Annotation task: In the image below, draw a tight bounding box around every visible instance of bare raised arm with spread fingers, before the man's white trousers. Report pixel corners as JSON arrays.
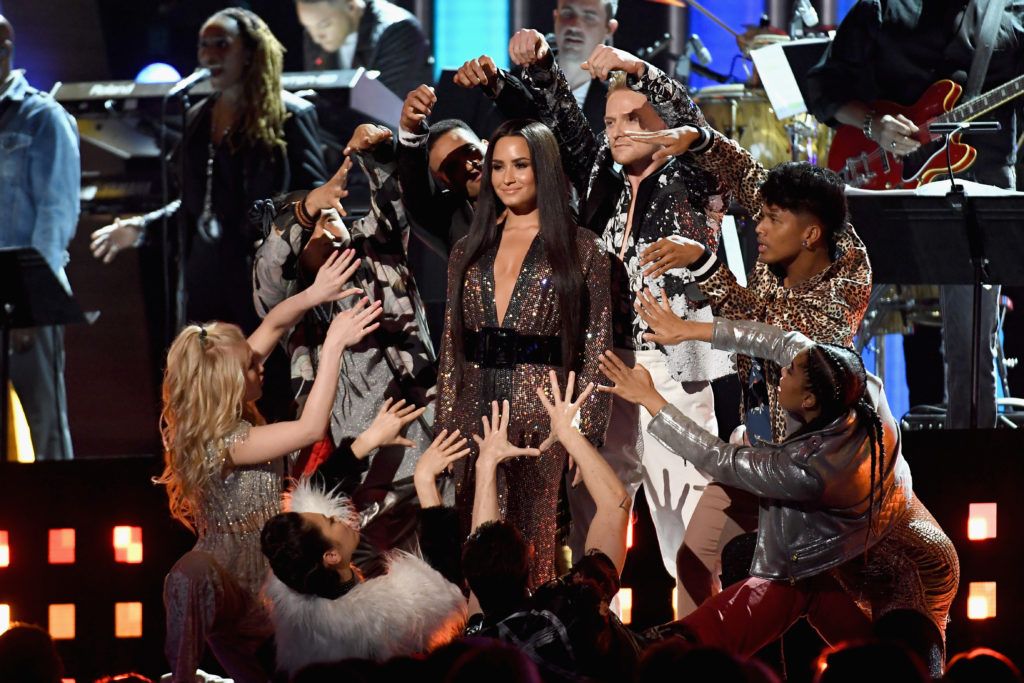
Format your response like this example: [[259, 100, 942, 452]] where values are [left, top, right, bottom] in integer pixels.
[[537, 371, 632, 573]]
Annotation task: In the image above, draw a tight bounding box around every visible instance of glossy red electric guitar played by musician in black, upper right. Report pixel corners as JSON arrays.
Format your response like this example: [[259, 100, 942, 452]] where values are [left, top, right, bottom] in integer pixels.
[[828, 76, 1024, 189]]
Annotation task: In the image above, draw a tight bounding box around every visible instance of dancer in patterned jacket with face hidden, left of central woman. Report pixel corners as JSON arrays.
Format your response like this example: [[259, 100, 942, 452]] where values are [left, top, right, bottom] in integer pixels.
[[253, 124, 437, 574]]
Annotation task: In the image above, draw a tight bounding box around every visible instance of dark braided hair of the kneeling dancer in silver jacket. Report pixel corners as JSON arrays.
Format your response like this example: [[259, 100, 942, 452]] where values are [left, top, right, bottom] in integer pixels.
[[807, 344, 886, 540]]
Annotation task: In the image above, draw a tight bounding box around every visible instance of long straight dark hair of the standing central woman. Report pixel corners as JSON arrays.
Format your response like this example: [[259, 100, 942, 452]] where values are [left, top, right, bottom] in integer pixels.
[[449, 120, 587, 378]]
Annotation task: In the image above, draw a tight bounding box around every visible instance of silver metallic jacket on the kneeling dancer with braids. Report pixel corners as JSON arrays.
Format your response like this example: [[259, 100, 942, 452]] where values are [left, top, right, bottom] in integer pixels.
[[647, 317, 913, 581]]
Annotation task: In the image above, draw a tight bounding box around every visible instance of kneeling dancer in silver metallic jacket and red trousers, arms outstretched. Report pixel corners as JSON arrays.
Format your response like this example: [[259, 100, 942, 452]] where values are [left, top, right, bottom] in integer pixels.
[[601, 318, 959, 674]]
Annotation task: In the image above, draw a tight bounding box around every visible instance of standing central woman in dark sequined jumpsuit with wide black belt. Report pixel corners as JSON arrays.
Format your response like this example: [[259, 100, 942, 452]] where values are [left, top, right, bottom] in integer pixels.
[[435, 121, 611, 586]]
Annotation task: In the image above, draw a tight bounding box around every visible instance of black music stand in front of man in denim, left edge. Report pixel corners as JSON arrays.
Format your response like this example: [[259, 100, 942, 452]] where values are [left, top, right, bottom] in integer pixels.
[[0, 247, 99, 462]]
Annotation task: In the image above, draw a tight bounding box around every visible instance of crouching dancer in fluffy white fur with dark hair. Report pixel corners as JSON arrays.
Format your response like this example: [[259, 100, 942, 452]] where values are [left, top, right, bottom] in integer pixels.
[[261, 434, 469, 677]]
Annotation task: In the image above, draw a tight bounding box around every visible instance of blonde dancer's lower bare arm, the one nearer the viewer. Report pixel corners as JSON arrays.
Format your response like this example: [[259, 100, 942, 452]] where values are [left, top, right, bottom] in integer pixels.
[[229, 299, 381, 465]]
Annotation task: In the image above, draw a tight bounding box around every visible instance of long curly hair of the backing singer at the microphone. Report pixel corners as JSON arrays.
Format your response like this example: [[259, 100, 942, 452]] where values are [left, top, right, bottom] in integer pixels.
[[204, 7, 289, 150]]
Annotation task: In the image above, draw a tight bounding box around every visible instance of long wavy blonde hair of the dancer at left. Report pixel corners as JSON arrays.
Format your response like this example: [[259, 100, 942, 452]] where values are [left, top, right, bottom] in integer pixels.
[[155, 323, 263, 530]]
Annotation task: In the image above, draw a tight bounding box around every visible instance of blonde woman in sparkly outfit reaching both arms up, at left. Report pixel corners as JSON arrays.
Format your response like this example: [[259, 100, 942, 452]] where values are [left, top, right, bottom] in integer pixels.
[[159, 250, 380, 683]]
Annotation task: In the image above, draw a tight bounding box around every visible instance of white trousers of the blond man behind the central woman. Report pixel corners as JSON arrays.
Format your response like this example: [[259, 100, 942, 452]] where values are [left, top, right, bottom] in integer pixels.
[[568, 349, 718, 578]]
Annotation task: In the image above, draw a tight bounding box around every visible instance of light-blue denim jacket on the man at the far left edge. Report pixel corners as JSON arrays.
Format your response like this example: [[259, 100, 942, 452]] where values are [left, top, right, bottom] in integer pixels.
[[0, 66, 81, 287]]
